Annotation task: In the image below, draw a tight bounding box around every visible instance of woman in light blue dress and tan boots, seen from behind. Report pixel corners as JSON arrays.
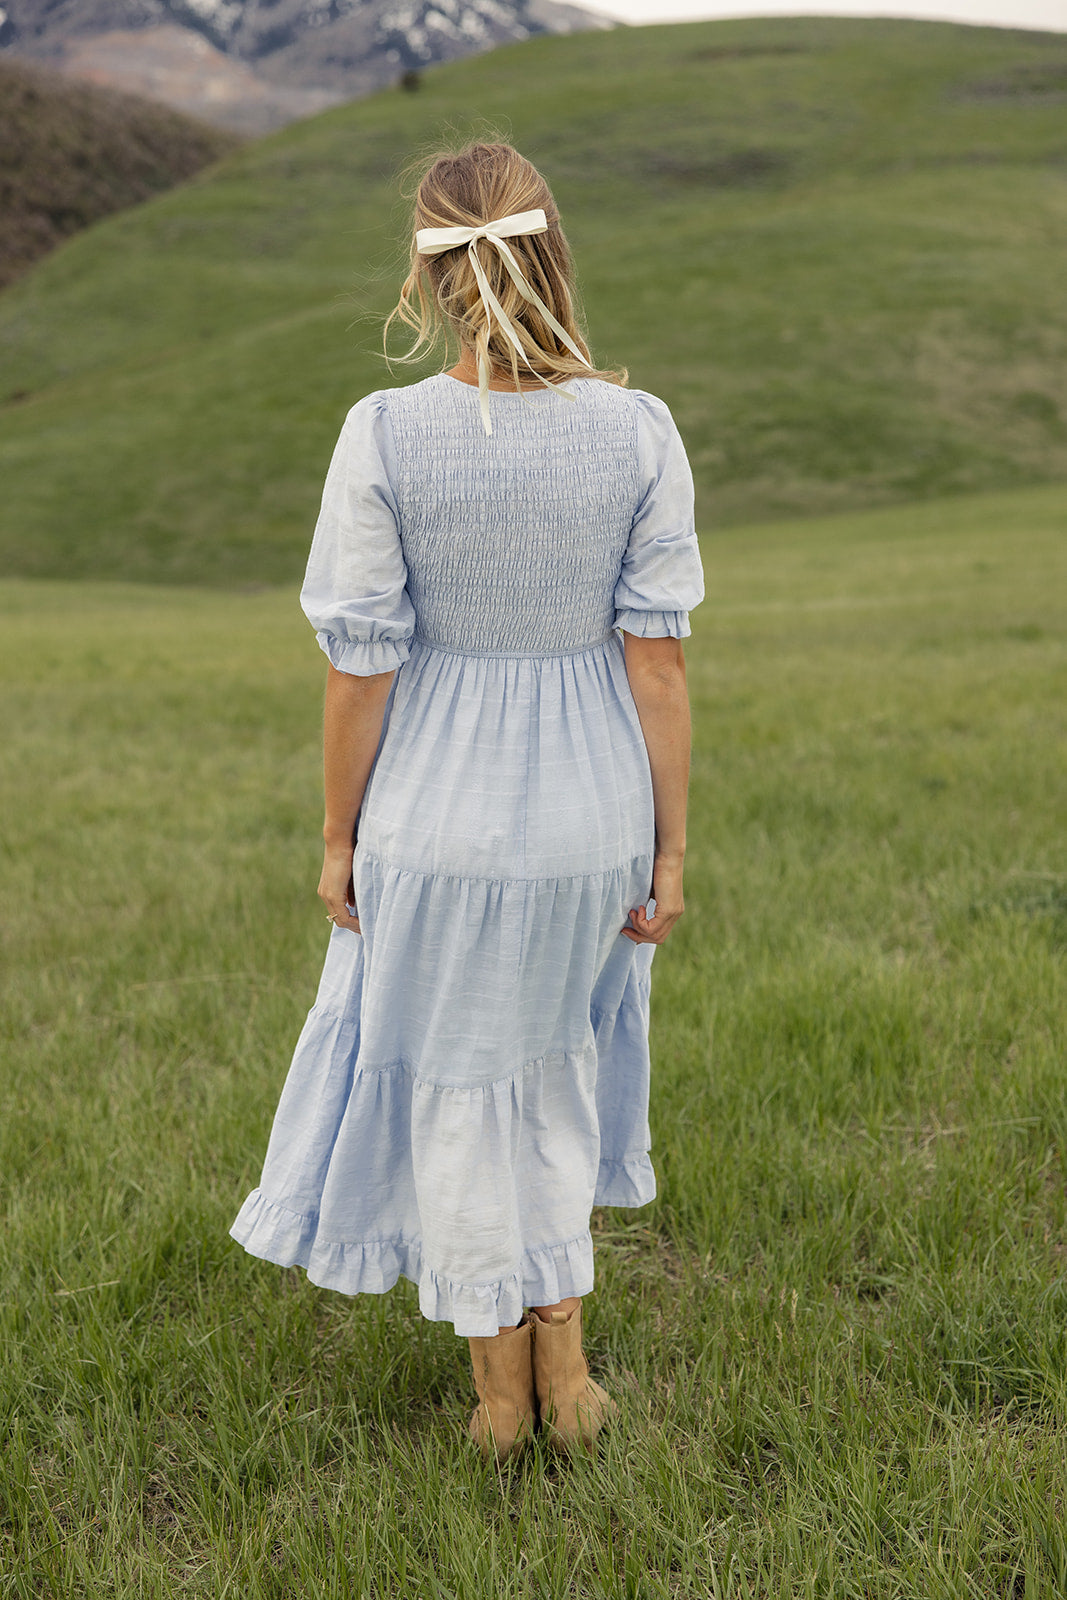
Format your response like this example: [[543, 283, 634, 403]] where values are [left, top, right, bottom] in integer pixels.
[[232, 144, 702, 1458]]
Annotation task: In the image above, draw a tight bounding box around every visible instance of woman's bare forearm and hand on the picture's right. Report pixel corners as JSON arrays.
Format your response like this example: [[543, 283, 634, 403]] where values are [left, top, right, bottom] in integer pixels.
[[622, 632, 691, 944]]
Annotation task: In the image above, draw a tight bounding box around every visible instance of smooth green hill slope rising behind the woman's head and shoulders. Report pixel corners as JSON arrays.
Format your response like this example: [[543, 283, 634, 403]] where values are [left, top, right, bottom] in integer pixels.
[[0, 18, 1067, 586]]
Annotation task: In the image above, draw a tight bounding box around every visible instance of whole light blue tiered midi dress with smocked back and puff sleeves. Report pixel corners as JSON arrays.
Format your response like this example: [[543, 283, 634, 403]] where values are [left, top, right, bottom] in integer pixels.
[[232, 374, 704, 1334]]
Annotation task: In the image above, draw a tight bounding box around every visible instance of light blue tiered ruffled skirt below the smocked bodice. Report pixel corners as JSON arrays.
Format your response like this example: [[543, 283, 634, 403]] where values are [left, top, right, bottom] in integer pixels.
[[232, 635, 656, 1336]]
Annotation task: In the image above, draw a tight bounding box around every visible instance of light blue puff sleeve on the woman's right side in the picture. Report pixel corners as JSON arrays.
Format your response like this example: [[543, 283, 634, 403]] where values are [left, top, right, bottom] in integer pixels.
[[614, 390, 704, 638]]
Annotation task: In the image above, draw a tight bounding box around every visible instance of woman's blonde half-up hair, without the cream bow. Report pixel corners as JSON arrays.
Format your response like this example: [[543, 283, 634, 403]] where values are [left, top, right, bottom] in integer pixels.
[[382, 142, 627, 389]]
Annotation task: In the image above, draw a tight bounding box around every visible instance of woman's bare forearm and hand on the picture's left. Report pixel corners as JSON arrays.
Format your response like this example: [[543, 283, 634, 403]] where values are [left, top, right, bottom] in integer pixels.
[[318, 666, 395, 933]]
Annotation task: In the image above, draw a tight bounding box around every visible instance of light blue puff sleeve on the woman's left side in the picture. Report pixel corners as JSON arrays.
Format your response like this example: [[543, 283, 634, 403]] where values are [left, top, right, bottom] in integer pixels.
[[301, 394, 414, 677]]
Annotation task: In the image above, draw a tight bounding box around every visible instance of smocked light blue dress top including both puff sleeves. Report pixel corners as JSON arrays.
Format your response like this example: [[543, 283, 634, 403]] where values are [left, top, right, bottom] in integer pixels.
[[301, 376, 704, 675]]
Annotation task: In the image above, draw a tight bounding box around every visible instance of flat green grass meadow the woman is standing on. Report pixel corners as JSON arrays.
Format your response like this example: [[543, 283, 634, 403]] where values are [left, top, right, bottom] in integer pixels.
[[0, 490, 1067, 1600]]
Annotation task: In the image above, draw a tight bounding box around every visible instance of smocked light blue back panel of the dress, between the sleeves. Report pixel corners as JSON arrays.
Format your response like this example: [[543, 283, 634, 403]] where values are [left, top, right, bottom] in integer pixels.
[[389, 378, 638, 654]]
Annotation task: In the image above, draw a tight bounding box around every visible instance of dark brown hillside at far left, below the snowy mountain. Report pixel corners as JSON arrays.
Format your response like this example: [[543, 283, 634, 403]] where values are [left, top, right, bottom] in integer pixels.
[[0, 58, 235, 286]]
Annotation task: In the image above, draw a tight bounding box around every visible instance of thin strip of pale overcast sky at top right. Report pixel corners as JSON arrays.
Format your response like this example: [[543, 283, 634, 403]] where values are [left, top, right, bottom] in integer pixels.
[[576, 0, 1067, 34]]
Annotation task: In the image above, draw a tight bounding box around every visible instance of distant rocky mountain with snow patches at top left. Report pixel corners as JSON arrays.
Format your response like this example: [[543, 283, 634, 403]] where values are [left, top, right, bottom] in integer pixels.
[[0, 0, 609, 133]]
